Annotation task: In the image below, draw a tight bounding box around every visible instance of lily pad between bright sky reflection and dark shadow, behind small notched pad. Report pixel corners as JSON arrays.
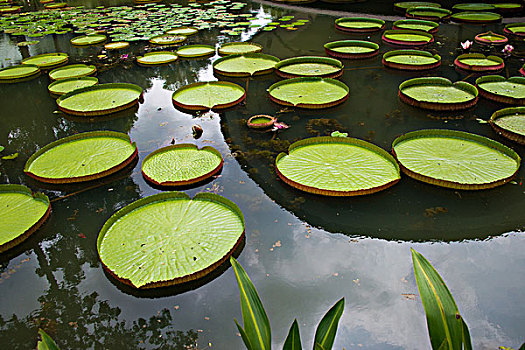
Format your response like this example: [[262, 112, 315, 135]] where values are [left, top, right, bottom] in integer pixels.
[[172, 81, 246, 111]]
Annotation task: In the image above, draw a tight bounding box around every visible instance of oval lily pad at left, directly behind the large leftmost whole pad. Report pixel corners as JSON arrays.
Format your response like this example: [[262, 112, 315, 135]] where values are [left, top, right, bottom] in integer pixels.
[[57, 83, 142, 116]]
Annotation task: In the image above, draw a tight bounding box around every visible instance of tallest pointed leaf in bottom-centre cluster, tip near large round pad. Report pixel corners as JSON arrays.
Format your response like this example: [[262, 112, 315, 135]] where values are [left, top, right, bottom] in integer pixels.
[[230, 258, 271, 350]]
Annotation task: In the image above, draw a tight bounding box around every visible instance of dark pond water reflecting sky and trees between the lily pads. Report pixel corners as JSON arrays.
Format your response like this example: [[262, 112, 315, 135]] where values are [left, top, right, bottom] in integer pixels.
[[0, 1, 525, 349]]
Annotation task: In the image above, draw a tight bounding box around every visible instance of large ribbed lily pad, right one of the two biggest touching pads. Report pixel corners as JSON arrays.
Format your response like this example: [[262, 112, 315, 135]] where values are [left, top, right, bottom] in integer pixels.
[[392, 130, 521, 190]]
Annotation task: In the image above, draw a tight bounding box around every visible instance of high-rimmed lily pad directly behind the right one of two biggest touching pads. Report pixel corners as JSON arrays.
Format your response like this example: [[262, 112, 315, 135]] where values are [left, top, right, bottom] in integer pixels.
[[399, 77, 478, 111]]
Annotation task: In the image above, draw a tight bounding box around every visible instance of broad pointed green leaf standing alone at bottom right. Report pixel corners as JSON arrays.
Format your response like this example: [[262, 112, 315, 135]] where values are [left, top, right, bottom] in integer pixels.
[[412, 249, 464, 349]]
